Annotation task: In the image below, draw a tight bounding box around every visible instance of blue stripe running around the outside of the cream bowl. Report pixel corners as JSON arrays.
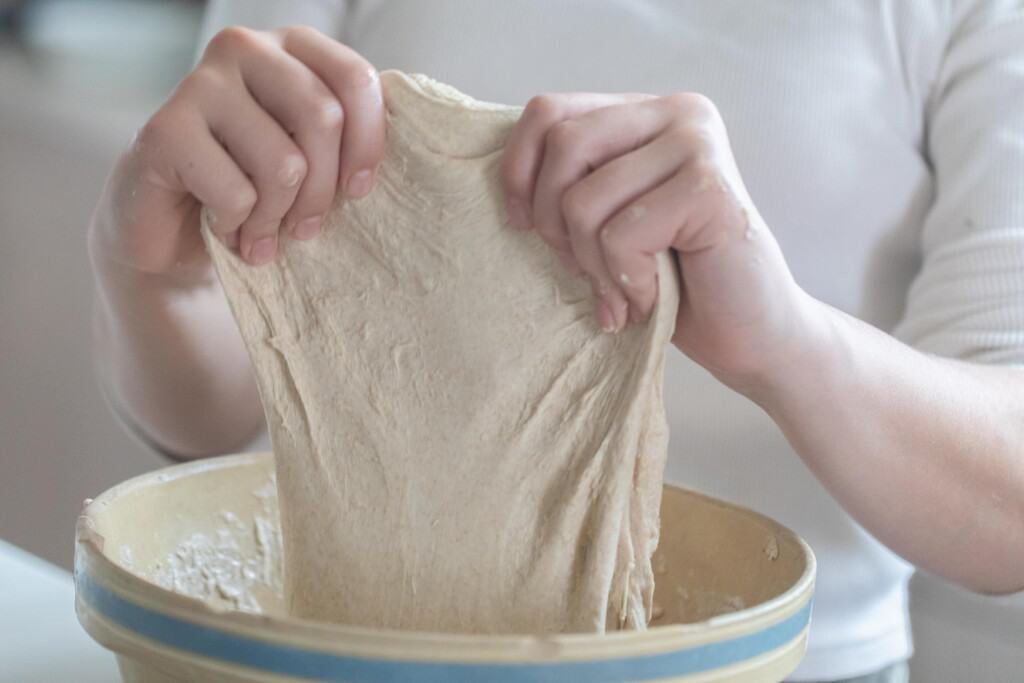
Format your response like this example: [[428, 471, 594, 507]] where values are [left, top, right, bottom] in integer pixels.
[[76, 572, 811, 683]]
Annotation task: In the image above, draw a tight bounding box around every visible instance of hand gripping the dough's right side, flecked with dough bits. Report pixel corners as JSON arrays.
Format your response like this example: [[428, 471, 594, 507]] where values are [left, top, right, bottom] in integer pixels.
[[502, 93, 807, 385]]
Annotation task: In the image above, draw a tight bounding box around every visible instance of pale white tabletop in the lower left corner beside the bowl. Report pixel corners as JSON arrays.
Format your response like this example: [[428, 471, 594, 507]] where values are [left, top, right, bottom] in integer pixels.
[[0, 541, 121, 683]]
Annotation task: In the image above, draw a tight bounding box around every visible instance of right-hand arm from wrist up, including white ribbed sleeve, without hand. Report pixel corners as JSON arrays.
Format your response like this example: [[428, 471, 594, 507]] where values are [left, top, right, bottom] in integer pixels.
[[752, 2, 1024, 593]]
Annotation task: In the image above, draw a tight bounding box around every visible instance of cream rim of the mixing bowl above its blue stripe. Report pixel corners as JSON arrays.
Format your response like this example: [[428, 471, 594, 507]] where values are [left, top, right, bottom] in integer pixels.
[[75, 452, 817, 661]]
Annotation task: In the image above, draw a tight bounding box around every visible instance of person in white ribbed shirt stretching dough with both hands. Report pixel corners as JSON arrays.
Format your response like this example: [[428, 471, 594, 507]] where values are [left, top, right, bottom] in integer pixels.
[[90, 0, 1024, 681]]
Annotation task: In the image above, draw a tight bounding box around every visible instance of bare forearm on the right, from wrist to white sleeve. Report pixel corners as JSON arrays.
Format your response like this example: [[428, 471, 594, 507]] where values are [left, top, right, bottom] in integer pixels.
[[752, 300, 1024, 593]]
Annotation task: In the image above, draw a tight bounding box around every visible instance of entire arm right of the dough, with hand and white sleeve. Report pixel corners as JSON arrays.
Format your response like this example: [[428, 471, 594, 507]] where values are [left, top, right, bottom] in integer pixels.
[[503, 3, 1024, 593]]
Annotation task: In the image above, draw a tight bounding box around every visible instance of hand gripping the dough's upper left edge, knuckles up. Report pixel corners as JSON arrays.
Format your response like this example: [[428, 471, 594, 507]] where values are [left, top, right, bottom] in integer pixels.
[[90, 27, 385, 275]]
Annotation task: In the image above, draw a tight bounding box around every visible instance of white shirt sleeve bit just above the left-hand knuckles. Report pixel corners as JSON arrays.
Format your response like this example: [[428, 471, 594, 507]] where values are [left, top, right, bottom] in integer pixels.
[[199, 0, 345, 54]]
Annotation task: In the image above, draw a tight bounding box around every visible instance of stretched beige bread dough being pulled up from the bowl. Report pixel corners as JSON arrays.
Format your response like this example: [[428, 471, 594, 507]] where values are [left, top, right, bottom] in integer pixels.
[[204, 72, 678, 633]]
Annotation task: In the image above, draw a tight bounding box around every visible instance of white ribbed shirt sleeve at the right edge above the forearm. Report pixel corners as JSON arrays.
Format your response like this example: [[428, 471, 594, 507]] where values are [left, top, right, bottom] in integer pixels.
[[893, 0, 1024, 365]]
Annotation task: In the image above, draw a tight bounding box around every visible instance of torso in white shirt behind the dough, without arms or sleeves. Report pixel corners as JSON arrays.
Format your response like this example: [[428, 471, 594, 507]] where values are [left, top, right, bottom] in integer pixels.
[[211, 0, 950, 677]]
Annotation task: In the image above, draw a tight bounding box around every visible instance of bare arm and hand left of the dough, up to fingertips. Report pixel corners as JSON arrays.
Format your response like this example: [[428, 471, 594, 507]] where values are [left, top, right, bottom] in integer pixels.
[[89, 22, 384, 456]]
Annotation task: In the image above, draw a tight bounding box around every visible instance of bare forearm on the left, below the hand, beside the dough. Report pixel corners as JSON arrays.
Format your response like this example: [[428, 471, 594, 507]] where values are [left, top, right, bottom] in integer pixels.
[[91, 217, 263, 456]]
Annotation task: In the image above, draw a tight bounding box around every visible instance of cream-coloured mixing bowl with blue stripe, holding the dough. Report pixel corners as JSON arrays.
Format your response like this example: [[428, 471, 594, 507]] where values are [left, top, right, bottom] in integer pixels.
[[75, 454, 814, 683]]
